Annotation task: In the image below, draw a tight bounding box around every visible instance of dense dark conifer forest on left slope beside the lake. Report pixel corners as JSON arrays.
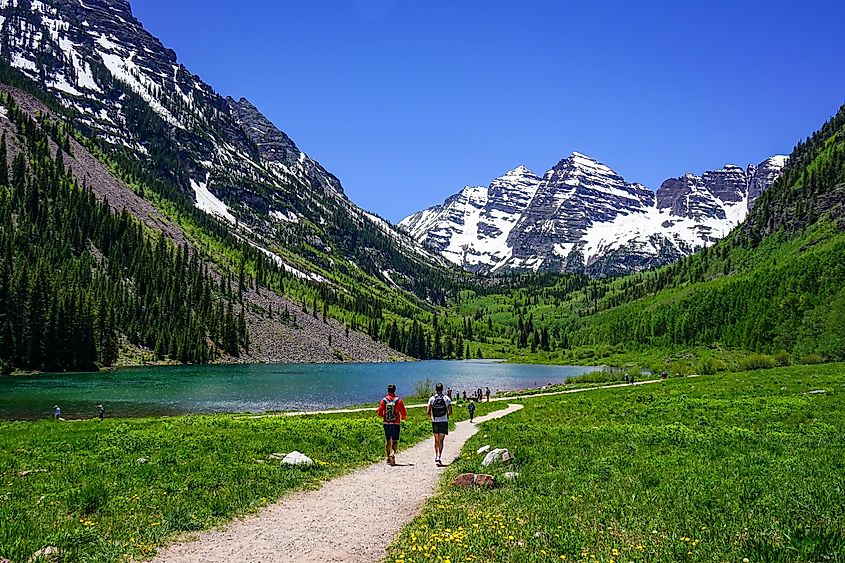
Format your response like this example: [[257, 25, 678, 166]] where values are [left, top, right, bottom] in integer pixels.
[[0, 95, 248, 371]]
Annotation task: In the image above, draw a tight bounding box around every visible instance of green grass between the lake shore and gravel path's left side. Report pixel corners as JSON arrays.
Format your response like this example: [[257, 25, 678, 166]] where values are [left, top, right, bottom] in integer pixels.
[[0, 404, 502, 562]]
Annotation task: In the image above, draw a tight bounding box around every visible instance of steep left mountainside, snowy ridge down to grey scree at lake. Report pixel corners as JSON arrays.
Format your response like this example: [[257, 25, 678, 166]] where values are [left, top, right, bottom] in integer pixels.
[[0, 0, 458, 361]]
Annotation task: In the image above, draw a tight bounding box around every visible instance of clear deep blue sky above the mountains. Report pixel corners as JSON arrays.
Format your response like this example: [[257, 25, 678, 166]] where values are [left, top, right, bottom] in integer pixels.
[[132, 0, 845, 225]]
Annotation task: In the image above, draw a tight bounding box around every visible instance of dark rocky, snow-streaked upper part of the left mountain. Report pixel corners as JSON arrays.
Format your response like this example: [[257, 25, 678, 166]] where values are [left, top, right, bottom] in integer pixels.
[[0, 0, 443, 285]]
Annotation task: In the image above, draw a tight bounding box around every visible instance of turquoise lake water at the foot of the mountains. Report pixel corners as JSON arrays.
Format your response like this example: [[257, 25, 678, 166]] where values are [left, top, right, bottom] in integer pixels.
[[0, 360, 597, 420]]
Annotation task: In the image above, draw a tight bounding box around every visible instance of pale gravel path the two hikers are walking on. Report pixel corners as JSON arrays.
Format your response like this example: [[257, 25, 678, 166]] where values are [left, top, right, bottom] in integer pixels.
[[153, 404, 522, 563]]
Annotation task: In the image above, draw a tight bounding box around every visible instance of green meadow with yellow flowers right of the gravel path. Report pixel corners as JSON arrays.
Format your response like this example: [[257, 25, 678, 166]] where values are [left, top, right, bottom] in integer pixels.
[[390, 364, 845, 563]]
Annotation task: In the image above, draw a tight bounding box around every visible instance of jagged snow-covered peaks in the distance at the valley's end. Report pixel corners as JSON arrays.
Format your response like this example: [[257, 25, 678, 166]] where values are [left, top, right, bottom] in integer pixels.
[[399, 152, 786, 275]]
